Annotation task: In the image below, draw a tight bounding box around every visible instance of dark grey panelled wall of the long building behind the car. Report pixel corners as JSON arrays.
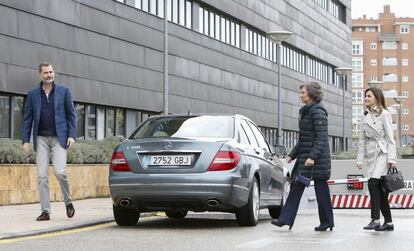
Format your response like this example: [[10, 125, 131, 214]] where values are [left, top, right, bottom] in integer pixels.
[[0, 0, 351, 151]]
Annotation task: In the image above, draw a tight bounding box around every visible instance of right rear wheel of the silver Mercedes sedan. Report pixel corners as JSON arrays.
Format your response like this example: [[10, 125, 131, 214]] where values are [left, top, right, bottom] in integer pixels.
[[236, 179, 260, 226]]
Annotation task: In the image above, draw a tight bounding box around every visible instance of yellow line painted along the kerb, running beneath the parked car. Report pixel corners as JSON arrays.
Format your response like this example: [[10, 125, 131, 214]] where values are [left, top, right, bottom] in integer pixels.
[[0, 216, 159, 245]]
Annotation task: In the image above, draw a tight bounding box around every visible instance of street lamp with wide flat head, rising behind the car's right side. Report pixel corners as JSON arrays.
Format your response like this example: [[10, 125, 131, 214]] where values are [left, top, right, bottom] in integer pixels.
[[266, 31, 292, 145]]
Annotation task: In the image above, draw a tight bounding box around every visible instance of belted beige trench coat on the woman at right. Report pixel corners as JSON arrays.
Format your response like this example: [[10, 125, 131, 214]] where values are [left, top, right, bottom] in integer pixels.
[[357, 109, 397, 179]]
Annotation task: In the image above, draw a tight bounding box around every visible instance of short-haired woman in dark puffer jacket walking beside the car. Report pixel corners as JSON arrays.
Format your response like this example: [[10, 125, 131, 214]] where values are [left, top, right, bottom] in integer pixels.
[[272, 82, 334, 231]]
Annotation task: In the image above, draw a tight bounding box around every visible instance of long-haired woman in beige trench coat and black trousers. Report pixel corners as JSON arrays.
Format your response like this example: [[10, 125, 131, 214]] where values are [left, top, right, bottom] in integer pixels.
[[357, 87, 397, 231]]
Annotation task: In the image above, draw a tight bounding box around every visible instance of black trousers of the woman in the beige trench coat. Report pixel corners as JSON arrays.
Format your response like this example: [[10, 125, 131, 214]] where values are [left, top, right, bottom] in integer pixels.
[[368, 178, 392, 222]]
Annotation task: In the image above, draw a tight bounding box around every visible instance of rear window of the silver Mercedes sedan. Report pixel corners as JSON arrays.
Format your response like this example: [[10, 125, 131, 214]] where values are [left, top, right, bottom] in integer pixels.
[[131, 116, 234, 139]]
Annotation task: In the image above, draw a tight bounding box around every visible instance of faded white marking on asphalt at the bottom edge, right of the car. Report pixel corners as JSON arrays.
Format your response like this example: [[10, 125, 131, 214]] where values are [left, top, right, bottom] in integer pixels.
[[236, 237, 345, 248]]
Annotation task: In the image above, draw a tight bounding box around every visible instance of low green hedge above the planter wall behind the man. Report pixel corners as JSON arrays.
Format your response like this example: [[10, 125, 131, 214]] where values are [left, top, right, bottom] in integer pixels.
[[0, 137, 123, 164]]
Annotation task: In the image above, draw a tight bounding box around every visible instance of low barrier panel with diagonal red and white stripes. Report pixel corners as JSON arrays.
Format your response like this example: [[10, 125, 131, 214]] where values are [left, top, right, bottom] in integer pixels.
[[331, 194, 414, 208]]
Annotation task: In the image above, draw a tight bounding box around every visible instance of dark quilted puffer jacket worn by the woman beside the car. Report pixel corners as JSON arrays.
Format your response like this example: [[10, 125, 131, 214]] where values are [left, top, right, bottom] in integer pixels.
[[289, 103, 331, 180]]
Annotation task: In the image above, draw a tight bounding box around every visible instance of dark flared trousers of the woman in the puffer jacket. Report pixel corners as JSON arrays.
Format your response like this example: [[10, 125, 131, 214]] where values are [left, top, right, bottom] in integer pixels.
[[278, 180, 334, 226]]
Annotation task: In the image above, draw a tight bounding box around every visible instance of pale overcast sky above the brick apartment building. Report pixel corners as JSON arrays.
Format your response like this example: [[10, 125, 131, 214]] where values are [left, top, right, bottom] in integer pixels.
[[351, 0, 414, 19]]
